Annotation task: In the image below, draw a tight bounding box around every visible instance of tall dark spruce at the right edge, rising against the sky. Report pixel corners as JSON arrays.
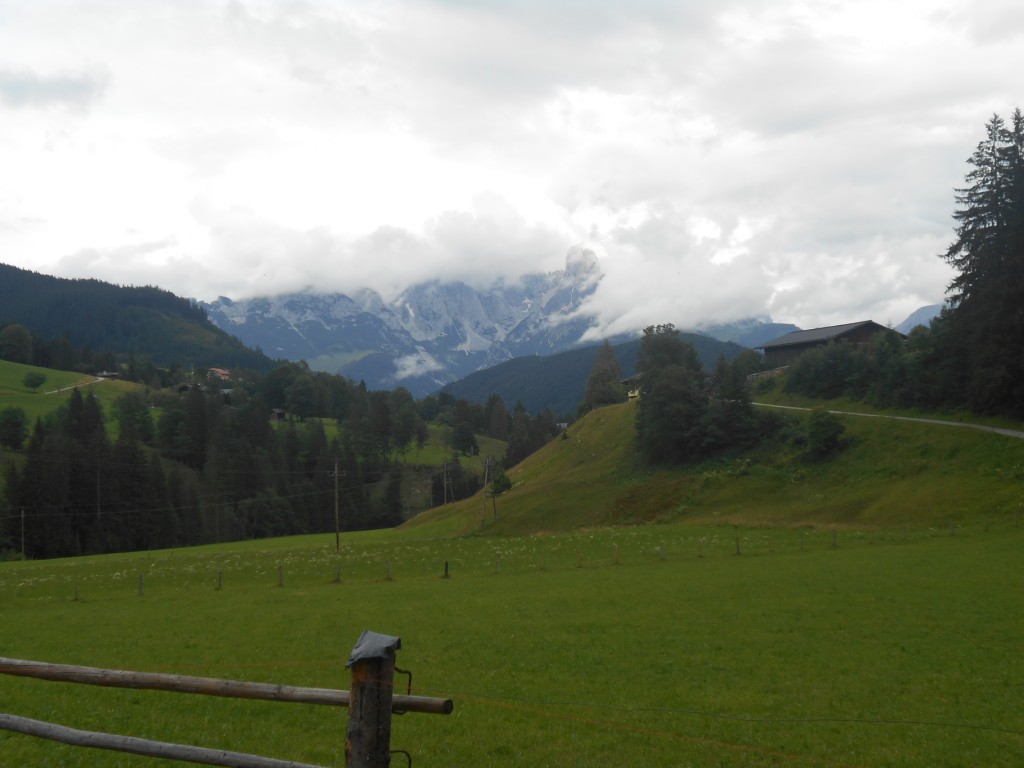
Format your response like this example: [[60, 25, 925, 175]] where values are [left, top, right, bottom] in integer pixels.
[[943, 109, 1024, 417]]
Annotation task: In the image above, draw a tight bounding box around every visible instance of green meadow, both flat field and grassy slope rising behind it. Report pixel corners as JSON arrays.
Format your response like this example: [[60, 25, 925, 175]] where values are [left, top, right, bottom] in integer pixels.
[[0, 367, 1024, 768]]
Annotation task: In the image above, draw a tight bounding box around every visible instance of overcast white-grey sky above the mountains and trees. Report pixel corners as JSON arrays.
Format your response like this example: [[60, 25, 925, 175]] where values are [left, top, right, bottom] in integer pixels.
[[0, 0, 1024, 332]]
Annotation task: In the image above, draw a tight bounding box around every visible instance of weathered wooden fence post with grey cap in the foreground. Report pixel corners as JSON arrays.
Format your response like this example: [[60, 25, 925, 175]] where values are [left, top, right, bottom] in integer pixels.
[[345, 630, 401, 768]]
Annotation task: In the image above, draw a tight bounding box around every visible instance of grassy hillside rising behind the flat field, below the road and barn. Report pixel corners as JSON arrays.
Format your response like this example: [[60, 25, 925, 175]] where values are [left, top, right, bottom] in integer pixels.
[[407, 393, 1024, 535]]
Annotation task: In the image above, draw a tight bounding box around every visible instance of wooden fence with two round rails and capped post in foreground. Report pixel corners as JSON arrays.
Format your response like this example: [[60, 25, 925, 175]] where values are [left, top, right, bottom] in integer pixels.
[[0, 631, 454, 768]]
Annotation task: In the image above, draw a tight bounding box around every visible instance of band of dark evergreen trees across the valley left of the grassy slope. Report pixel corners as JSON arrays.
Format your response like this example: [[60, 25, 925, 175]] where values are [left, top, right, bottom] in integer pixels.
[[0, 362, 554, 558]]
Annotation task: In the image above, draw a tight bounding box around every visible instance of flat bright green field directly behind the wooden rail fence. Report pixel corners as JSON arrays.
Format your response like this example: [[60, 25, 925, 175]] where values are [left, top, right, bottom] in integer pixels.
[[0, 524, 1024, 767]]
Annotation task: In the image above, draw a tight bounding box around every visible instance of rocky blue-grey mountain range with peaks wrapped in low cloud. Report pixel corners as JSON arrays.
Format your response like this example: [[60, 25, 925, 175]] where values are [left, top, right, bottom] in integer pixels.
[[202, 248, 819, 397]]
